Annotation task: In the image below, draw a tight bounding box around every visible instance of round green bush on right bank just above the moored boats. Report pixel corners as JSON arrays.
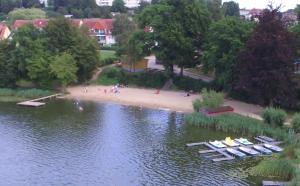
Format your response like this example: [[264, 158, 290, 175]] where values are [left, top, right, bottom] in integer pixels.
[[262, 107, 287, 127]]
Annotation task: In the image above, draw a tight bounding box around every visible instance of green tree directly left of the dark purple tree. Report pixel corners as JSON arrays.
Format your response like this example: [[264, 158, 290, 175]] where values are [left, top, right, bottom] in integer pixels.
[[203, 17, 253, 89]]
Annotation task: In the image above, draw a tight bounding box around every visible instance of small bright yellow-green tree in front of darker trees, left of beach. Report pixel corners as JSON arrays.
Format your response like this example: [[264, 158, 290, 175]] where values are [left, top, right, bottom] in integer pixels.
[[50, 53, 78, 87]]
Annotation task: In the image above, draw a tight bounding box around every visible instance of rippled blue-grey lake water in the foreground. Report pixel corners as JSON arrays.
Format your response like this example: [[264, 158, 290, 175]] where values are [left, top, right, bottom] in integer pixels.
[[0, 100, 260, 186]]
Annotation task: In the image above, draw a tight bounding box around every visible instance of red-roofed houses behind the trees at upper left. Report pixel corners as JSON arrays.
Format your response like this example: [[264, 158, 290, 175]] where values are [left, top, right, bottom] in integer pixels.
[[0, 18, 116, 45]]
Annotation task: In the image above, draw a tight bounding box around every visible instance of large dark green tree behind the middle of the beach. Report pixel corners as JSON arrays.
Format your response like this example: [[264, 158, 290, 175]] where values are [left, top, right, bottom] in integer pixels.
[[138, 0, 210, 72]]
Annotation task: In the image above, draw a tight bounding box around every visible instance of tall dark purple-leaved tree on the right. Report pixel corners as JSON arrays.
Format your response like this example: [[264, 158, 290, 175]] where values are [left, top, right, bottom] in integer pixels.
[[235, 9, 295, 106]]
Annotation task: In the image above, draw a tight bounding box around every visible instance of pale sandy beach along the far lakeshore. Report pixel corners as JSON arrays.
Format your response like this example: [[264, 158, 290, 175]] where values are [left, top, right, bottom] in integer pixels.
[[66, 86, 262, 119]]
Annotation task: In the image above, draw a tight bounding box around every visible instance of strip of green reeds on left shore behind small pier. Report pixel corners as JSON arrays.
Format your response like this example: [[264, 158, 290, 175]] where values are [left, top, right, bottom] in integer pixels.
[[0, 88, 53, 102]]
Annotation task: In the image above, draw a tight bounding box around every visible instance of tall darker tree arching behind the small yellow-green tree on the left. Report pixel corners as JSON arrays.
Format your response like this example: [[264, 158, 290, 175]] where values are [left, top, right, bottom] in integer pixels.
[[45, 18, 99, 82]]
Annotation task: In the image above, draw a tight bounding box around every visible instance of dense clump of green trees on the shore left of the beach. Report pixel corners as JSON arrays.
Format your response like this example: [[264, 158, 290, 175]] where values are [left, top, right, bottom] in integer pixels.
[[0, 19, 100, 87]]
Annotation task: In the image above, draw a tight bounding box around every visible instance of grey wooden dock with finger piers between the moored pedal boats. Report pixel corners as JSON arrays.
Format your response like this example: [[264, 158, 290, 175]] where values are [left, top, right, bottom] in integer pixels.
[[186, 137, 281, 162]]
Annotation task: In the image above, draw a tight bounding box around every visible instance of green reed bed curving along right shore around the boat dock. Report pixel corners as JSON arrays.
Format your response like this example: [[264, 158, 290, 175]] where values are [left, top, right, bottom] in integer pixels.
[[185, 113, 300, 183]]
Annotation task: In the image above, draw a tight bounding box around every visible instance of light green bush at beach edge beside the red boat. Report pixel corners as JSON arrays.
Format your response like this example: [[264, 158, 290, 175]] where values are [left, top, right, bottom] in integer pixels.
[[201, 89, 224, 108]]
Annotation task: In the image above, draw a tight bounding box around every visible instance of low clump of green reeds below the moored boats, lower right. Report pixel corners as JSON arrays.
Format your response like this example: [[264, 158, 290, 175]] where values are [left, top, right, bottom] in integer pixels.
[[250, 159, 295, 180]]
